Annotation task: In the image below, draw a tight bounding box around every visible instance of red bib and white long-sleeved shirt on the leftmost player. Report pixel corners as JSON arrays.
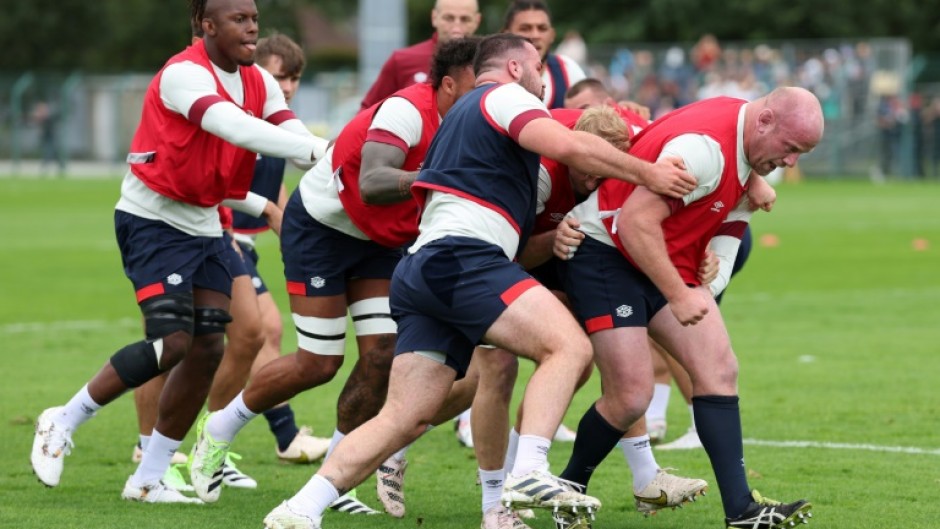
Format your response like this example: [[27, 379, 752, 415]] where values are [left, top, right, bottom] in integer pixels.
[[116, 40, 326, 236]]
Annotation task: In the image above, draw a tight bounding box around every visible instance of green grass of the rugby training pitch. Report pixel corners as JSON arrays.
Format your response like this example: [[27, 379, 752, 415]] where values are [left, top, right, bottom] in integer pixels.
[[0, 179, 940, 529]]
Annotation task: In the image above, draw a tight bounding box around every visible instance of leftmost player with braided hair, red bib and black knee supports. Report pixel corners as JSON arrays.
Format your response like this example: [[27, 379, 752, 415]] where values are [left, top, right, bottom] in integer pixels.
[[30, 0, 327, 503]]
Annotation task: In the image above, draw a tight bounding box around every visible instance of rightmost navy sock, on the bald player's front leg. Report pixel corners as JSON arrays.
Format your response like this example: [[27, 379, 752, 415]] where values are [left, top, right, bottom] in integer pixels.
[[692, 395, 751, 518]]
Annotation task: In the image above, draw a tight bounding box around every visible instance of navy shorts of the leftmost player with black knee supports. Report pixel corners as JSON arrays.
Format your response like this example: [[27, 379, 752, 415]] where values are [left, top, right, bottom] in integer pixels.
[[114, 210, 232, 303]]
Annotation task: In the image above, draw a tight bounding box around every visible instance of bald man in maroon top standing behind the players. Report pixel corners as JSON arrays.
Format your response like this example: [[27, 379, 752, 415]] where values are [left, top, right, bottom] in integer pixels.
[[360, 0, 480, 109]]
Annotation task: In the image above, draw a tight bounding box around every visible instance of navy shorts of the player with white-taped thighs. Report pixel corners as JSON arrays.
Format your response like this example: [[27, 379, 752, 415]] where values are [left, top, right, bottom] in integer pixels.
[[281, 191, 402, 296]]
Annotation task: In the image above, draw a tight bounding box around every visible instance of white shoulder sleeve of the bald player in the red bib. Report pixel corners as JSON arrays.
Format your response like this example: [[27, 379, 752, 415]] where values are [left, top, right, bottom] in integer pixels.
[[657, 134, 725, 205]]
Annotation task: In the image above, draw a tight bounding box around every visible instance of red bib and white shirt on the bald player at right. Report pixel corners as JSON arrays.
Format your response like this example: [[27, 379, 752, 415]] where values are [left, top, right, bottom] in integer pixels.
[[574, 98, 751, 285]]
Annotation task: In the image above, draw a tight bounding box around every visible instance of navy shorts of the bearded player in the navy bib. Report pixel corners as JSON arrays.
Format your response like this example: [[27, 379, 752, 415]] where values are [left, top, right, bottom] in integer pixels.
[[389, 237, 539, 378]]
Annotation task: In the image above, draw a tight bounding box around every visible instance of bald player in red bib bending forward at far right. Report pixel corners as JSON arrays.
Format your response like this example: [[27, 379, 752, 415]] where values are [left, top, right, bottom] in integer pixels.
[[561, 87, 823, 529]]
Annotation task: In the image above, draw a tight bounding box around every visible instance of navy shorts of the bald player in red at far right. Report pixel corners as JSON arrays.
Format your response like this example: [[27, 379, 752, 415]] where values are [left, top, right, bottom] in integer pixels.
[[564, 237, 666, 334]]
